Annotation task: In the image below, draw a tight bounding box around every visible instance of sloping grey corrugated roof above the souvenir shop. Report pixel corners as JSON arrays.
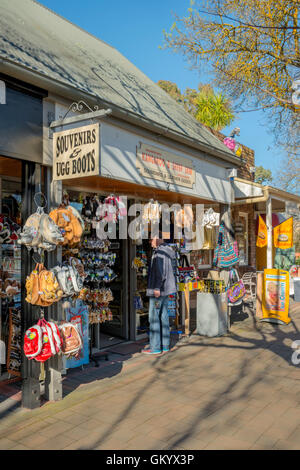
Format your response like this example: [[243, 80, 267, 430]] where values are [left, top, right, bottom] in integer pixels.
[[0, 0, 234, 158]]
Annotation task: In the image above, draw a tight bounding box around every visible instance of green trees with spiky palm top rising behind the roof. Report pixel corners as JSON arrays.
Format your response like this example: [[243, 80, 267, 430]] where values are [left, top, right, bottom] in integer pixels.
[[158, 80, 234, 131]]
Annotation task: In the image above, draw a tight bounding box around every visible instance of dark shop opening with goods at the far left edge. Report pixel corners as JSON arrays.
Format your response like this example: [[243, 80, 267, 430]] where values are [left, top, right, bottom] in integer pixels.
[[0, 157, 22, 384]]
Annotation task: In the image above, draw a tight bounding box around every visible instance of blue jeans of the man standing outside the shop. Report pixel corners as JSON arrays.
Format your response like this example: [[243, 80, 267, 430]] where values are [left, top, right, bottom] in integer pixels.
[[149, 296, 170, 351]]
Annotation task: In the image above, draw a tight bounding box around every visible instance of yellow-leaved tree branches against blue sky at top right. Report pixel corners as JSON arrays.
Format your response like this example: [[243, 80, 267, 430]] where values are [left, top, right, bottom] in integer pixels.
[[165, 0, 300, 151]]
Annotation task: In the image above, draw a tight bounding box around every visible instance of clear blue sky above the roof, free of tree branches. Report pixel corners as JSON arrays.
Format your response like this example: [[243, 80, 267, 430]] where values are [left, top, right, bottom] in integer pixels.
[[40, 0, 283, 176]]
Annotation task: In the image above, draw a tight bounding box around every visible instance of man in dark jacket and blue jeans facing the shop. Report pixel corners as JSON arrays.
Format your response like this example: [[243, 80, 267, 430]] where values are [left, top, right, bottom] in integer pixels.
[[143, 232, 176, 355]]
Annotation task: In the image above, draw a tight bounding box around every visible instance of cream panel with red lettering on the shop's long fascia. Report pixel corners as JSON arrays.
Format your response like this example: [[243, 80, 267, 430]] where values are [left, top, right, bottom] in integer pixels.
[[136, 143, 195, 188]]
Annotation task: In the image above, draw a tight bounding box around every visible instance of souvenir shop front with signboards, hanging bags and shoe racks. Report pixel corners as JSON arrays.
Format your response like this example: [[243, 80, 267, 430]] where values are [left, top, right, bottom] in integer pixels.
[[0, 98, 239, 408]]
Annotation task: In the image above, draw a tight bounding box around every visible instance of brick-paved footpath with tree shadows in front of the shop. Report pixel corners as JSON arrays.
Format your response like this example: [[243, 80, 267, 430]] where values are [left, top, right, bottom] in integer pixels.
[[0, 303, 300, 450]]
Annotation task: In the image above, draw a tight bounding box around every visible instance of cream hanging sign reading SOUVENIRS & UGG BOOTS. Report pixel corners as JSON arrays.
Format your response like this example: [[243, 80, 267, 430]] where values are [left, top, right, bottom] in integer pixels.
[[53, 124, 100, 181]]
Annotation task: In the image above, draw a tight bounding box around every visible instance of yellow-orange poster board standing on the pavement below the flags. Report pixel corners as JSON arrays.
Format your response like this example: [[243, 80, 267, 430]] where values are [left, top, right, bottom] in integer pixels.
[[262, 269, 291, 324]]
